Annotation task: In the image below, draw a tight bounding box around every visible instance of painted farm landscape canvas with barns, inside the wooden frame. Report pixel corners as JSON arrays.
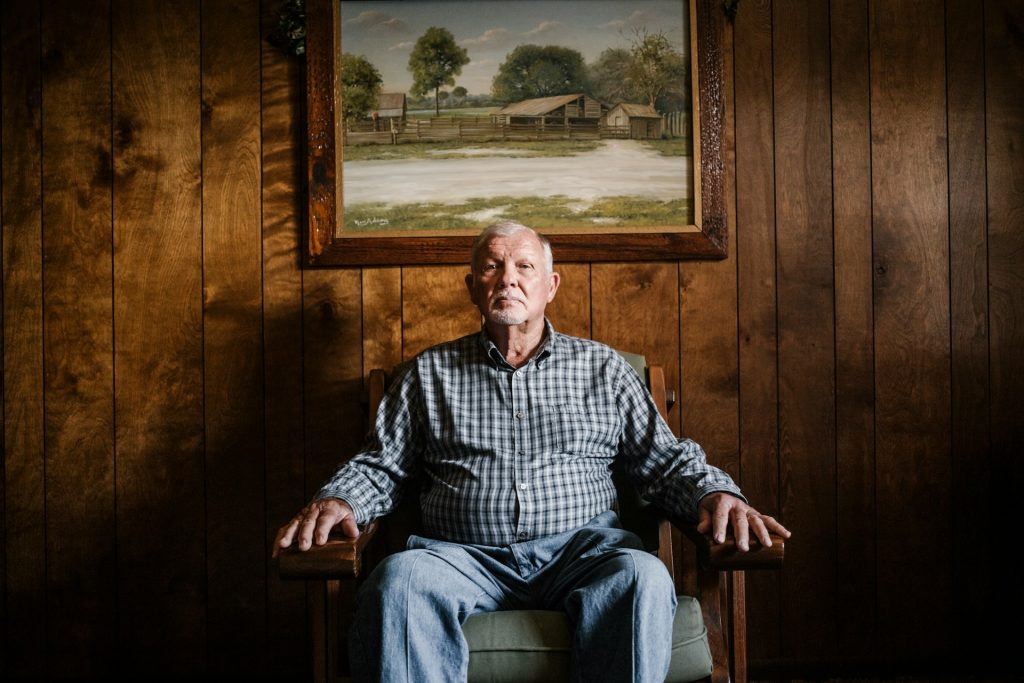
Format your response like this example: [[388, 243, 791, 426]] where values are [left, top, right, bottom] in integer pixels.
[[335, 0, 699, 238]]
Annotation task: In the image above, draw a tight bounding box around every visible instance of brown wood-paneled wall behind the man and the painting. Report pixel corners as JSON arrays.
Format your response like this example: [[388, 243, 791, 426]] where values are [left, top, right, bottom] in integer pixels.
[[0, 0, 1024, 680]]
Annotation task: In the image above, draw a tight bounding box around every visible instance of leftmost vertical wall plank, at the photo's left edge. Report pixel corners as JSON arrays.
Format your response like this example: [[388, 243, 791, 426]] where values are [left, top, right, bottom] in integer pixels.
[[0, 0, 46, 676]]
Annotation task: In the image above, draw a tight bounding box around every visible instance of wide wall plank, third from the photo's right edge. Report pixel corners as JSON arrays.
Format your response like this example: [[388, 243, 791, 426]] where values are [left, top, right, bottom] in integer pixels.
[[869, 0, 954, 660]]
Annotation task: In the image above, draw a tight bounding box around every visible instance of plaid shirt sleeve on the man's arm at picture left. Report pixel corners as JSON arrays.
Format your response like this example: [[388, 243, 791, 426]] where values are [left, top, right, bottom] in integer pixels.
[[313, 364, 424, 524]]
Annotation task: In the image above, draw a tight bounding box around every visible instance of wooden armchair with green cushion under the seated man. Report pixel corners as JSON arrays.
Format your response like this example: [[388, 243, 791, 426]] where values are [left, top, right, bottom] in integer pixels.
[[276, 353, 784, 683]]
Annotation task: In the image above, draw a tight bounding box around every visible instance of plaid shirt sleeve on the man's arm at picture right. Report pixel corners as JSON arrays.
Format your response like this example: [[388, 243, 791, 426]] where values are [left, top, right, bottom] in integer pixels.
[[615, 362, 746, 521]]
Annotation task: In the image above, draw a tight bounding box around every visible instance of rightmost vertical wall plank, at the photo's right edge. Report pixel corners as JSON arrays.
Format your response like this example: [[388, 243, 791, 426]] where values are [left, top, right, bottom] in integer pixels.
[[983, 0, 1024, 660]]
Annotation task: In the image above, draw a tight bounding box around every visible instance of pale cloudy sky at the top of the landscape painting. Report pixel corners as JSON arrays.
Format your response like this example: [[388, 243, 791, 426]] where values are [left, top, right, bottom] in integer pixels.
[[341, 0, 689, 94]]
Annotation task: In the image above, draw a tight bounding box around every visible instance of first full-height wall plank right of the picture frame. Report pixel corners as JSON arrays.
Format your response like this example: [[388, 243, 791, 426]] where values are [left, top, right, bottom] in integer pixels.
[[726, 2, 781, 659]]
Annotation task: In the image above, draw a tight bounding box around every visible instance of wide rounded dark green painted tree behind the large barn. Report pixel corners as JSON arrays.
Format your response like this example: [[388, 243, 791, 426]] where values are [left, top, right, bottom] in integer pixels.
[[490, 45, 589, 102]]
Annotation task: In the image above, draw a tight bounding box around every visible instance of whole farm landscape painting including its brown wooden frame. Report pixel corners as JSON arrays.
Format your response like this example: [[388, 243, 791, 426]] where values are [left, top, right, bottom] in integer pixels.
[[303, 0, 726, 267]]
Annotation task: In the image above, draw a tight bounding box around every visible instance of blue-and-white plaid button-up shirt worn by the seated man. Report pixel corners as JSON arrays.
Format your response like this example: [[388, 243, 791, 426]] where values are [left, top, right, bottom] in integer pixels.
[[316, 323, 741, 546]]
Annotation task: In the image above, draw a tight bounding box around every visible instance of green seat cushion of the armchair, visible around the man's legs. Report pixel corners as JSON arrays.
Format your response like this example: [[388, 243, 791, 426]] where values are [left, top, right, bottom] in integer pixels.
[[462, 596, 712, 683]]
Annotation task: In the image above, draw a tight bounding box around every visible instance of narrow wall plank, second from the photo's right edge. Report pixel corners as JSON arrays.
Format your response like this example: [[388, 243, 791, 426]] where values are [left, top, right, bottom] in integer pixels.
[[945, 0, 991, 659]]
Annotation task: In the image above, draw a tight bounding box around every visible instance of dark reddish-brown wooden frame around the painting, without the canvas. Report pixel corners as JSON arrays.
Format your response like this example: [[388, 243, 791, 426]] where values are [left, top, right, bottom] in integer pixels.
[[303, 0, 727, 267]]
